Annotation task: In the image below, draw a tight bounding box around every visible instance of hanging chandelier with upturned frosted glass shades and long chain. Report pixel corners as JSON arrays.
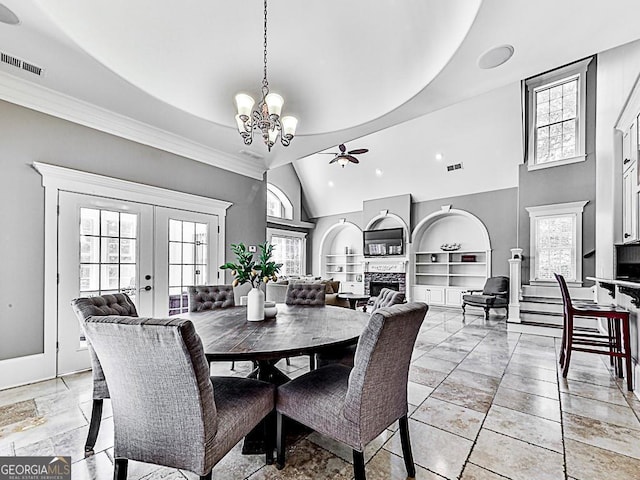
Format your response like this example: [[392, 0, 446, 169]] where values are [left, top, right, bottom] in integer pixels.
[[236, 0, 298, 151]]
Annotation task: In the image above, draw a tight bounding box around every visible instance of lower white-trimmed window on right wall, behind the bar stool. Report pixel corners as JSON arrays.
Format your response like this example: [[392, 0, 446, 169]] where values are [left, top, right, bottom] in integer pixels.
[[527, 201, 587, 284]]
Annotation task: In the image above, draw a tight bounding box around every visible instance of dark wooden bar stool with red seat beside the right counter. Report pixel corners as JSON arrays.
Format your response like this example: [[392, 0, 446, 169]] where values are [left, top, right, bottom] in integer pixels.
[[554, 273, 633, 392]]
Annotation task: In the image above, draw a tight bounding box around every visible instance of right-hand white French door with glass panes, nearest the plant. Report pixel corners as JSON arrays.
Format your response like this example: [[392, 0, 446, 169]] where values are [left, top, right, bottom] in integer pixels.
[[154, 207, 222, 317]]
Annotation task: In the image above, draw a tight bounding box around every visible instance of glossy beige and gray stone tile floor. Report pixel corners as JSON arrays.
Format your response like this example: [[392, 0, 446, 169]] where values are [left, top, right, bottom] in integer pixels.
[[0, 309, 640, 480]]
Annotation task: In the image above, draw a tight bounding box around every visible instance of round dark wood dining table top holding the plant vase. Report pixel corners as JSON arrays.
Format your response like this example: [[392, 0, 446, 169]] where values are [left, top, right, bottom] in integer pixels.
[[180, 303, 369, 361]]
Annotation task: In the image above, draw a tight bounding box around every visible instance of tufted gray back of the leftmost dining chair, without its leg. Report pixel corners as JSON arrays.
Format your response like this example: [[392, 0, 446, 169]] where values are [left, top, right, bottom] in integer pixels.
[[71, 293, 138, 400]]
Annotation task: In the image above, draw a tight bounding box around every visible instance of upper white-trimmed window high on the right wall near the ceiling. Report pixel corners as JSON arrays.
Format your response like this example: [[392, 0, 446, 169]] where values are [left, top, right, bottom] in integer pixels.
[[525, 59, 591, 170]]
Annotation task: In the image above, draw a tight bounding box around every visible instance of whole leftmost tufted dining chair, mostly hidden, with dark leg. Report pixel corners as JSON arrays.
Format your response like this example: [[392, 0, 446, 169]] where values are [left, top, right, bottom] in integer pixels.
[[71, 293, 138, 456]]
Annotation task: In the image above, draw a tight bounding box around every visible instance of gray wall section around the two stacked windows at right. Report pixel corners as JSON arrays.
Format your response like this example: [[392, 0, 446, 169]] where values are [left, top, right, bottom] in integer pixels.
[[518, 58, 597, 285]]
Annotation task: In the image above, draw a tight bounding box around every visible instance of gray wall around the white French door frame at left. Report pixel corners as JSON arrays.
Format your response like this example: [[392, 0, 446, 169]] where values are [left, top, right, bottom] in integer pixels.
[[0, 102, 266, 360]]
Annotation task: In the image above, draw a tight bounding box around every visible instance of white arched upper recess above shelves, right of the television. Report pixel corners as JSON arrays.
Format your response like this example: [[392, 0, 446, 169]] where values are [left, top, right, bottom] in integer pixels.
[[411, 207, 491, 252]]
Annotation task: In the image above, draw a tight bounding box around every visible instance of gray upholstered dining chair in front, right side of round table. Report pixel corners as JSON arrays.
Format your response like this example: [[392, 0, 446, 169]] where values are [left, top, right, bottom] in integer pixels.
[[276, 303, 429, 480]]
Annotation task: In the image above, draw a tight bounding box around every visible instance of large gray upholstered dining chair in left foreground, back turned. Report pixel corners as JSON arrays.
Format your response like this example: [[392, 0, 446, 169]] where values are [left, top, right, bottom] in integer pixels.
[[84, 316, 275, 480]]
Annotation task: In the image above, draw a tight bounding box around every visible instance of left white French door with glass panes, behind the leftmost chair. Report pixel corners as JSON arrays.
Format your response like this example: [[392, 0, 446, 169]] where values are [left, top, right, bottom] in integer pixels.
[[57, 192, 154, 375]]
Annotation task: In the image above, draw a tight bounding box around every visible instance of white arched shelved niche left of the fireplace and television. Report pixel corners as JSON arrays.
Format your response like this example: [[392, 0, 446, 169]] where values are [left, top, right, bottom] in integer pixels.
[[319, 221, 363, 282]]
